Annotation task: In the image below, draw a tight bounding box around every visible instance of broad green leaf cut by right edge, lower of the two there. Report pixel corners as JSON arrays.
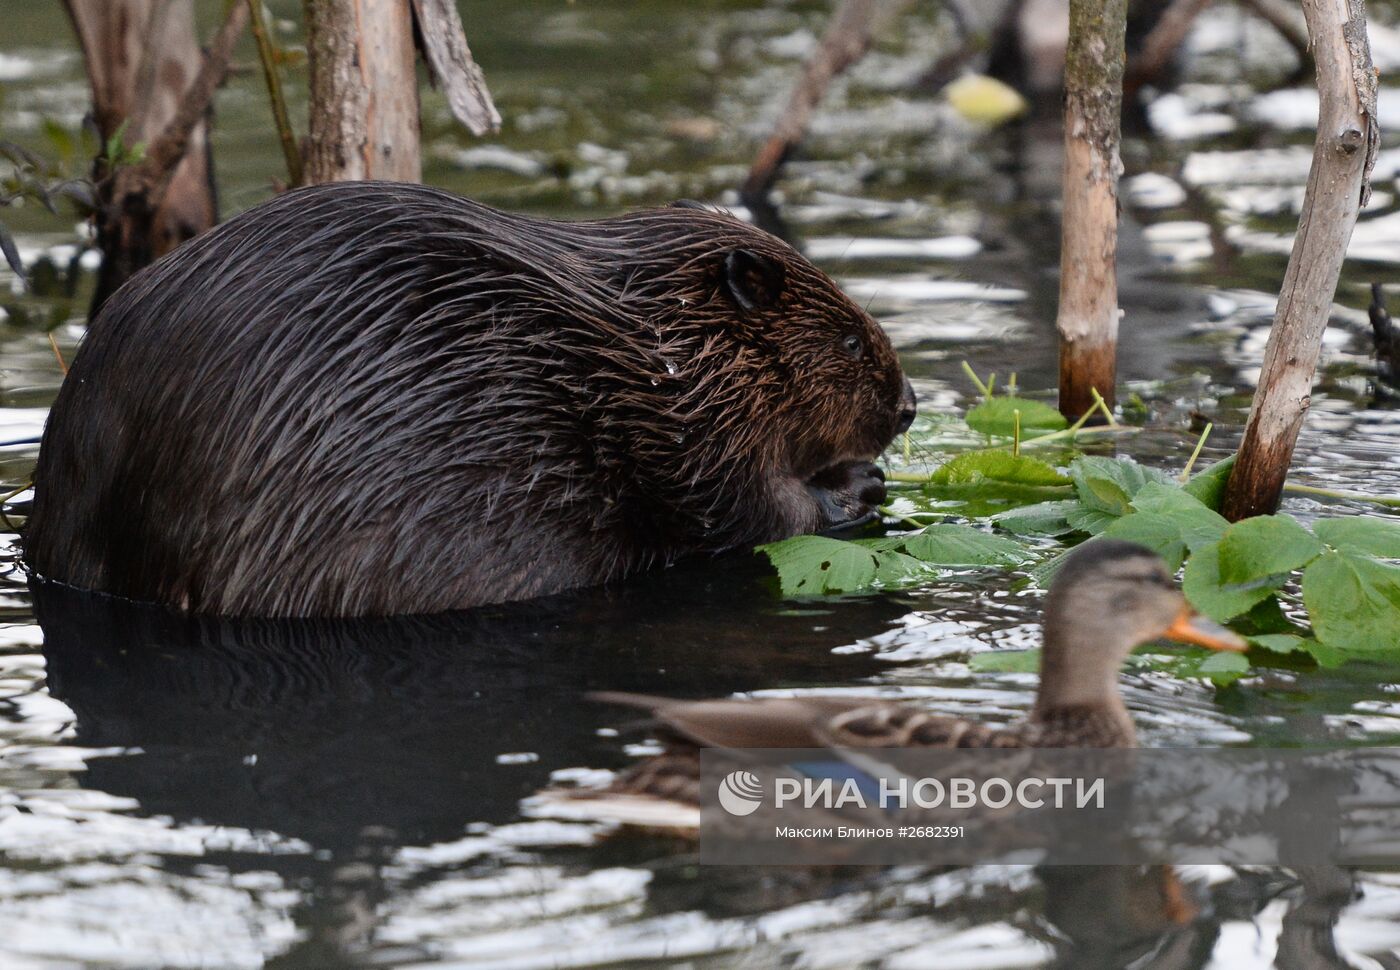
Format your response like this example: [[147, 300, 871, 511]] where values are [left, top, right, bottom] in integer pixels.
[[1303, 551, 1400, 652]]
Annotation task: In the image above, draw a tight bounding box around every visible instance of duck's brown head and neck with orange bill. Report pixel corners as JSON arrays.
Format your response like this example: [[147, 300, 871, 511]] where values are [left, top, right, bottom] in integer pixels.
[[1037, 539, 1246, 710]]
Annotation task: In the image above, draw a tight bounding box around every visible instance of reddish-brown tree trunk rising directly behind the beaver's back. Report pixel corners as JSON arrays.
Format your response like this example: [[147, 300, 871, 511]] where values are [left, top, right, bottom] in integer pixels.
[[305, 0, 423, 182]]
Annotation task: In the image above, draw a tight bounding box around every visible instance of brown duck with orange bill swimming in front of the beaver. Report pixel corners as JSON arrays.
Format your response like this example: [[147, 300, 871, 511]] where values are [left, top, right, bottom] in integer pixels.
[[526, 537, 1247, 829]]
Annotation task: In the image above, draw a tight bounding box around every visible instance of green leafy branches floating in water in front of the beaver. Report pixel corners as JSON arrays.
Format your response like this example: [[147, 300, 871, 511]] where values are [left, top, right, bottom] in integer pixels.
[[759, 366, 1400, 684]]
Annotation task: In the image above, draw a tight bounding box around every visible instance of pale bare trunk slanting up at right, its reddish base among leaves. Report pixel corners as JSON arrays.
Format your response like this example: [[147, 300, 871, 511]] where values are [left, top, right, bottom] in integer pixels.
[[1222, 0, 1380, 521]]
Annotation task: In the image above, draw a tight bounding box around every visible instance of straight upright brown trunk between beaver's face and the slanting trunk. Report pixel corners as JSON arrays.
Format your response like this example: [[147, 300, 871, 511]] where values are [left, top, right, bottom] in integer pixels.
[[1056, 0, 1127, 420]]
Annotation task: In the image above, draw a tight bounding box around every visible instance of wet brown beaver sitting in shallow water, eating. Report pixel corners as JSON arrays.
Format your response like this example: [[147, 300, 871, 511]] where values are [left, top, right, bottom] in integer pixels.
[[22, 182, 914, 616]]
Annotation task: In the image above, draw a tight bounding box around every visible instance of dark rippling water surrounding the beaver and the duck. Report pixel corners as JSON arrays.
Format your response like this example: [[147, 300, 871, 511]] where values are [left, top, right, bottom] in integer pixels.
[[0, 0, 1400, 970]]
